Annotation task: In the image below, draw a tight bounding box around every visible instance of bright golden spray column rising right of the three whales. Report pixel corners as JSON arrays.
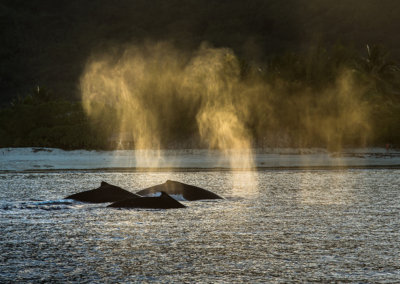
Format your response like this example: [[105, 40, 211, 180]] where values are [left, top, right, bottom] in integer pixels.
[[185, 47, 253, 168]]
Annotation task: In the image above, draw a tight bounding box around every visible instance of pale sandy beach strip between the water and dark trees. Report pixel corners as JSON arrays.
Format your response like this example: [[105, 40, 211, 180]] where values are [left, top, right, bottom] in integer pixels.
[[0, 147, 400, 173]]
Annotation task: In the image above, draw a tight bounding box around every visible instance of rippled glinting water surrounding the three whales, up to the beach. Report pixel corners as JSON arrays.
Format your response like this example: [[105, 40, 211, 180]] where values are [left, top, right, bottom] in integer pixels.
[[0, 170, 400, 283]]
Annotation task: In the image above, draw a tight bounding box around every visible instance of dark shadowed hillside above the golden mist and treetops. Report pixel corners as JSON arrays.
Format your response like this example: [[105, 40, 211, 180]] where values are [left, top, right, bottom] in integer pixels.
[[0, 0, 400, 103]]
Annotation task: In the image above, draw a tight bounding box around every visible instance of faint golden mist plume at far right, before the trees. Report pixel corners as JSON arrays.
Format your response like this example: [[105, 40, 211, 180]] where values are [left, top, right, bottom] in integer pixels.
[[297, 70, 371, 151]]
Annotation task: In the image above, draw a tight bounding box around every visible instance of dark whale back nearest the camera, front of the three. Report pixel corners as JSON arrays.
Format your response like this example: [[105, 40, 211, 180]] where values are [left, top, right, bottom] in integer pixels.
[[107, 192, 186, 209]]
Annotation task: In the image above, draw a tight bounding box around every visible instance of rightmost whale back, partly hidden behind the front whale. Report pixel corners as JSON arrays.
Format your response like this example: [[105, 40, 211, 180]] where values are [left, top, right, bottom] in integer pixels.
[[136, 180, 223, 201]]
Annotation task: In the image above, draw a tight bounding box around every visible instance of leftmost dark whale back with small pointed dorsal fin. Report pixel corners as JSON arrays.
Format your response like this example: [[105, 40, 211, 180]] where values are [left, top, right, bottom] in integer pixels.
[[65, 181, 140, 203]]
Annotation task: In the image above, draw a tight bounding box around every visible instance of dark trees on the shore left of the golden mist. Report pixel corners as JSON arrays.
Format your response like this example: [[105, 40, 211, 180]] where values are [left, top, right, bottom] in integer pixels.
[[0, 88, 107, 149]]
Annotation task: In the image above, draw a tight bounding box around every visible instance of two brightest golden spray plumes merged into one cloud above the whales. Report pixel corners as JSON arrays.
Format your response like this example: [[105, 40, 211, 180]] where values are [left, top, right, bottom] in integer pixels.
[[81, 42, 260, 173]]
